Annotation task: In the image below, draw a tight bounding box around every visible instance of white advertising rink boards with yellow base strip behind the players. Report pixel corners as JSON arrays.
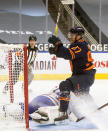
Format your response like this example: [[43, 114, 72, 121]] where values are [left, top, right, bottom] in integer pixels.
[[0, 52, 108, 81]]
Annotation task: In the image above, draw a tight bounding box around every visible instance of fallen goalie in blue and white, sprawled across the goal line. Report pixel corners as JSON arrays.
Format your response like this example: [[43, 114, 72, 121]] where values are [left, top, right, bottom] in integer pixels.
[[0, 86, 60, 123]]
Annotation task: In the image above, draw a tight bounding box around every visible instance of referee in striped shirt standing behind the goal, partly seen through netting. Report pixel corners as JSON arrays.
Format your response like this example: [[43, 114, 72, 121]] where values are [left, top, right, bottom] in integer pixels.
[[3, 35, 38, 93]]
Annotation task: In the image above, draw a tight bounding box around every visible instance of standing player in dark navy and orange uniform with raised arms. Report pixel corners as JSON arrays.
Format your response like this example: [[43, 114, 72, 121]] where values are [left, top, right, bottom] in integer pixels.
[[48, 27, 96, 122]]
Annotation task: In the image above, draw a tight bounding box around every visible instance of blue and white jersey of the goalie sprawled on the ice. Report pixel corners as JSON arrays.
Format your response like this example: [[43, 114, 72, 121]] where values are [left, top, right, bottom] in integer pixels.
[[29, 87, 60, 114]]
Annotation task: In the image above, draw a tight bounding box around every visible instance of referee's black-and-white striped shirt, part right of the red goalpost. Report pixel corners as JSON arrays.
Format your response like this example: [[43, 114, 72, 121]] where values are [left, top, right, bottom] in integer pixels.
[[27, 46, 38, 65]]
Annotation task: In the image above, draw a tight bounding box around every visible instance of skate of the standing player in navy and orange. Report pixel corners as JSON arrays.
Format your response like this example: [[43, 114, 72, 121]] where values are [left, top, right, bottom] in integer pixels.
[[54, 112, 69, 125]]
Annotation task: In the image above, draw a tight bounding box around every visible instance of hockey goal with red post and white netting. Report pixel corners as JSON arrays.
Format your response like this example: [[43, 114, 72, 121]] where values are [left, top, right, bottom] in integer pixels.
[[0, 44, 29, 128]]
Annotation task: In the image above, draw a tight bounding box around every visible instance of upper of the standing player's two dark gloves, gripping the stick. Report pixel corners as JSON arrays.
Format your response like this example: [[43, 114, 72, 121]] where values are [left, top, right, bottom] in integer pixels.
[[48, 35, 63, 46]]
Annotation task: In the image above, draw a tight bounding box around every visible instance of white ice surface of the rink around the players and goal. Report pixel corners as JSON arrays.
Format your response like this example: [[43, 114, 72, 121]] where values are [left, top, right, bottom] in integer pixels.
[[0, 80, 108, 131]]
